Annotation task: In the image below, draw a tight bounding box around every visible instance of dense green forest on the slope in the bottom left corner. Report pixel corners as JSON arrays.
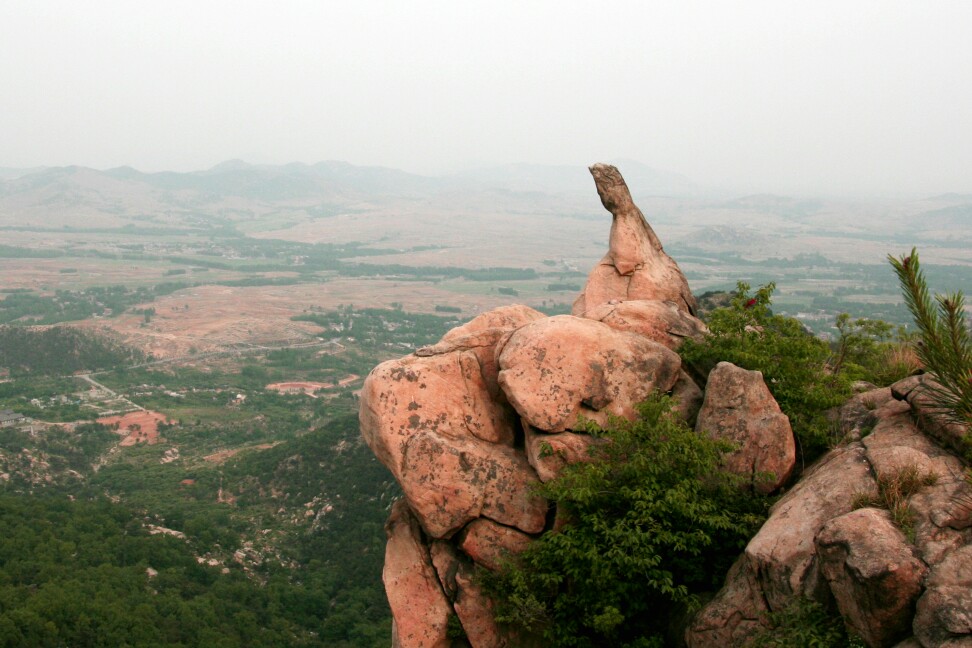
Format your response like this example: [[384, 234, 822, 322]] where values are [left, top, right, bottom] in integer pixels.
[[0, 496, 374, 647]]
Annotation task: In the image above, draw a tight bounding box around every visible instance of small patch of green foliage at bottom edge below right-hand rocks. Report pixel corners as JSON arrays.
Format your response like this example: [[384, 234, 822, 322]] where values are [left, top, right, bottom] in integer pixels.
[[746, 599, 865, 648]]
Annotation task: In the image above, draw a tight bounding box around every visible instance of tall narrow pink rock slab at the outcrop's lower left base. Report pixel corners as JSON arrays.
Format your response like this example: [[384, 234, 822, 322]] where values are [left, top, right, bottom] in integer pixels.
[[382, 500, 452, 648]]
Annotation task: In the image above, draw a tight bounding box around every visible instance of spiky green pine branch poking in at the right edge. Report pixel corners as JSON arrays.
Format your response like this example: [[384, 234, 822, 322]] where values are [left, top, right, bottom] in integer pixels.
[[888, 248, 972, 425]]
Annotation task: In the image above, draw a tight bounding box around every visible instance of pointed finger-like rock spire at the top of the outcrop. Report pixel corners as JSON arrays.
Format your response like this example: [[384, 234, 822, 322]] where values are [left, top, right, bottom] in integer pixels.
[[571, 164, 696, 317]]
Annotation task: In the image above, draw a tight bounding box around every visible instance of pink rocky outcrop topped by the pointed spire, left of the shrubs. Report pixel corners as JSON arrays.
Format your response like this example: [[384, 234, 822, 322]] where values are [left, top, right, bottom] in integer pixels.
[[360, 165, 706, 648]]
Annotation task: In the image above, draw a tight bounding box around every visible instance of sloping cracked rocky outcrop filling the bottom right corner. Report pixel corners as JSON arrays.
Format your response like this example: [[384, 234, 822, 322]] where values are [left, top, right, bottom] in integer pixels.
[[685, 380, 972, 648]]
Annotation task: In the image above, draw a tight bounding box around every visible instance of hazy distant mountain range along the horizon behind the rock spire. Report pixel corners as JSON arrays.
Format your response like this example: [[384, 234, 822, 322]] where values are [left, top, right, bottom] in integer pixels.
[[0, 160, 972, 249]]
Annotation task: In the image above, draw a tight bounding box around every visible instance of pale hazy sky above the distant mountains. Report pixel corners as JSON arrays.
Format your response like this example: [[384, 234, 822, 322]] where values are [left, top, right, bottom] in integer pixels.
[[0, 0, 972, 194]]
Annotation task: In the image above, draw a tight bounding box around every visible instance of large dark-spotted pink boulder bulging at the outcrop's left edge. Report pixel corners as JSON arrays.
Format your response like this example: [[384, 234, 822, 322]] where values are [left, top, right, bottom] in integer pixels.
[[360, 351, 546, 537]]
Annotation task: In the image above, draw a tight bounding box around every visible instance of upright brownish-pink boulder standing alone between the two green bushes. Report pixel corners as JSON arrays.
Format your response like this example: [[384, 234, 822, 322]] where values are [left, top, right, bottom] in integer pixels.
[[695, 362, 796, 493]]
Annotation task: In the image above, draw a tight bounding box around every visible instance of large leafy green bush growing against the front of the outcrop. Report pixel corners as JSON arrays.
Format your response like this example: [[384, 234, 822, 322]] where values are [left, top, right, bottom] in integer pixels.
[[483, 396, 766, 647]]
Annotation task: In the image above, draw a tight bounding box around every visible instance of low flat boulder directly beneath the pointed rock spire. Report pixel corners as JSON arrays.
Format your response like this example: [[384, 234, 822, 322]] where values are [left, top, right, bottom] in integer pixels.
[[584, 299, 709, 350]]
